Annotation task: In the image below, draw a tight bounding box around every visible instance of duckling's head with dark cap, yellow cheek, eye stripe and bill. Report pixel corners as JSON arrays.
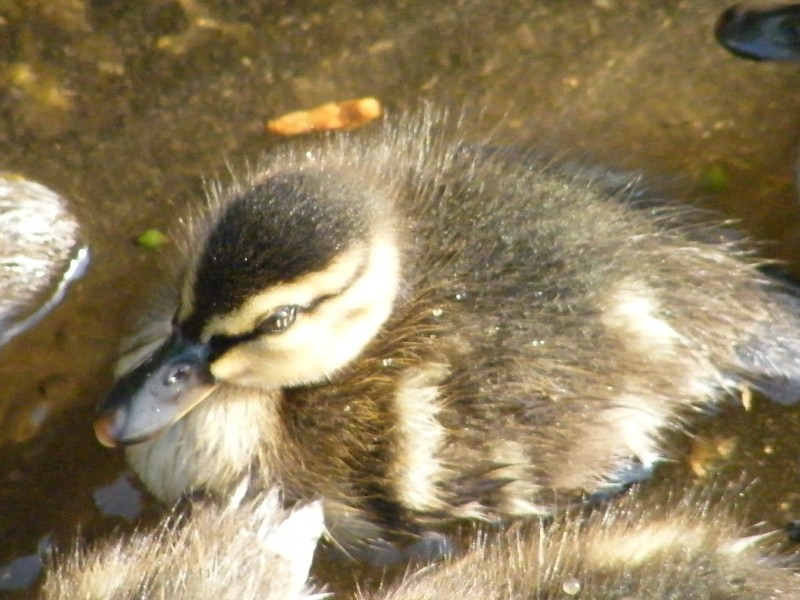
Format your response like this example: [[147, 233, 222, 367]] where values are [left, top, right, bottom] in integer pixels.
[[95, 169, 399, 446]]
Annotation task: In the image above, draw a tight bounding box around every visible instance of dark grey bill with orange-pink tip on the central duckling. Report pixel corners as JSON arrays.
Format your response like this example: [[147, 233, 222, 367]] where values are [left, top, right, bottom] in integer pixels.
[[94, 333, 217, 448]]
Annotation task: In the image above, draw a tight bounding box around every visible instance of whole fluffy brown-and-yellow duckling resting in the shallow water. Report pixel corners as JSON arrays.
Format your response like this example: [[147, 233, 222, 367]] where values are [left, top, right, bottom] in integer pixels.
[[95, 111, 800, 543]]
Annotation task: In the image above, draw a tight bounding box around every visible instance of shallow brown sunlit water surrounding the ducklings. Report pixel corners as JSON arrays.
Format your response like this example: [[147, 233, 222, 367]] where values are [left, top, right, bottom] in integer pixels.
[[0, 0, 800, 597]]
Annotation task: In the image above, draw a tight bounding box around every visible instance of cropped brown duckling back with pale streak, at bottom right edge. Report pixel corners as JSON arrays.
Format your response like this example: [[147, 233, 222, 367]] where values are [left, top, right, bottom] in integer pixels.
[[372, 496, 800, 600]]
